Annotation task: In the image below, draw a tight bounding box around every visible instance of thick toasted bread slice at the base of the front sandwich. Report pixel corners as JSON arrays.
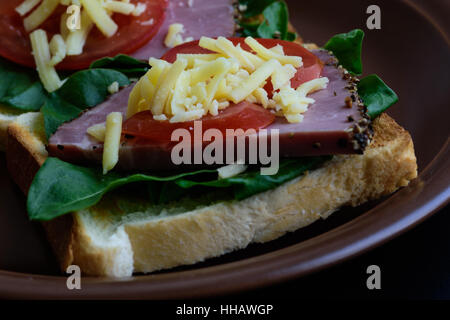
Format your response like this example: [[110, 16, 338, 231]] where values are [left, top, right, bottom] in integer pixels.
[[7, 113, 417, 277]]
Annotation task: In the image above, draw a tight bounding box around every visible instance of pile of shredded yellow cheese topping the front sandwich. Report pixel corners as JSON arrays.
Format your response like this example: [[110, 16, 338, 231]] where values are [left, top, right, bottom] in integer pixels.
[[127, 37, 328, 123]]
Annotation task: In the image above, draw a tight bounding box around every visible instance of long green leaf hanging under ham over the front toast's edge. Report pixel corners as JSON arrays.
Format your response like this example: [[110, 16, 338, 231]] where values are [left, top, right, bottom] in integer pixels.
[[27, 157, 328, 221]]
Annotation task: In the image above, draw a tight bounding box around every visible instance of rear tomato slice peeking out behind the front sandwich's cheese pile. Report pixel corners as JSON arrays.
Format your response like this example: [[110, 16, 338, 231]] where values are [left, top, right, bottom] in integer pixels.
[[162, 38, 323, 92]]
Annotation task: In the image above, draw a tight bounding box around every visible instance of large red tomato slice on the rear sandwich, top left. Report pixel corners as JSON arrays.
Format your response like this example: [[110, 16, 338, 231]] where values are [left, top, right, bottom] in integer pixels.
[[0, 0, 168, 70]]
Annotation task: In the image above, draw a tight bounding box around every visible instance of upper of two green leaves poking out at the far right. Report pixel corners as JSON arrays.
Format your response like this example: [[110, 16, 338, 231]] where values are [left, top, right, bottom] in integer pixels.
[[324, 29, 364, 75]]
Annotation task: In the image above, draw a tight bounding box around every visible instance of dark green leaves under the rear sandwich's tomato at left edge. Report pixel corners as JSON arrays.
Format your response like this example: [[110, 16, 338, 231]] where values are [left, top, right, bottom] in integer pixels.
[[0, 56, 130, 137]]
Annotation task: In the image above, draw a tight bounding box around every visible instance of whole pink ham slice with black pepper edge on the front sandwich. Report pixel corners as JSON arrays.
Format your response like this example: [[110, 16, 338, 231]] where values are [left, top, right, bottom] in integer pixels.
[[48, 51, 372, 170]]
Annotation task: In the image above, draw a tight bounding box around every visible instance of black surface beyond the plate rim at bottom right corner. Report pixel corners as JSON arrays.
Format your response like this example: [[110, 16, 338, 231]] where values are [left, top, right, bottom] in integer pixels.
[[236, 206, 450, 301]]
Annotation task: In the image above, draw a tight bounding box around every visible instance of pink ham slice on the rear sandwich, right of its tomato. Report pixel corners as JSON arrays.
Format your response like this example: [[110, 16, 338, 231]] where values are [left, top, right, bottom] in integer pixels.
[[132, 0, 235, 60]]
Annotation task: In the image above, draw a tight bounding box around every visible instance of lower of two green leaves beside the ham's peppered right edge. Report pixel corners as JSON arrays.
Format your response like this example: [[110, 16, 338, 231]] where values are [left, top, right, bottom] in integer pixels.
[[358, 74, 398, 119]]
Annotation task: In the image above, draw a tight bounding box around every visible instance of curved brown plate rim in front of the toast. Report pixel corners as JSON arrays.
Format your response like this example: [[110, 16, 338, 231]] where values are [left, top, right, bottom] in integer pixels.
[[0, 138, 450, 299]]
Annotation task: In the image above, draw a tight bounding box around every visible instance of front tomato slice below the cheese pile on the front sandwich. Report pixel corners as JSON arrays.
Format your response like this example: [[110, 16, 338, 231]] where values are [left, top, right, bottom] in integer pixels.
[[122, 102, 275, 144]]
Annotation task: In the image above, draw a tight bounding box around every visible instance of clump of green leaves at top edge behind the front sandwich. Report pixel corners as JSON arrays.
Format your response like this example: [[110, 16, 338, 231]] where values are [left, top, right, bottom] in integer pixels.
[[240, 0, 297, 41]]
